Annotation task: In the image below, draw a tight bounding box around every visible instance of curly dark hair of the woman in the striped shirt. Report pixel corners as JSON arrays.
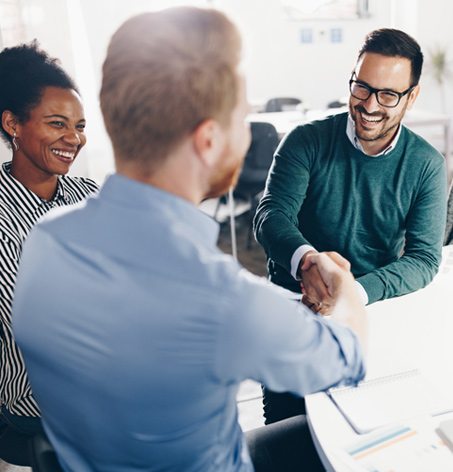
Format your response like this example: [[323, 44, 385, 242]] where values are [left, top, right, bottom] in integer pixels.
[[0, 39, 79, 146]]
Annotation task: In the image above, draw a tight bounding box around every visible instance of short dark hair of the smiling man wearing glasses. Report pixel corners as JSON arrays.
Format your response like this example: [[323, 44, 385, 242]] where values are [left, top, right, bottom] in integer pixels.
[[358, 28, 423, 86]]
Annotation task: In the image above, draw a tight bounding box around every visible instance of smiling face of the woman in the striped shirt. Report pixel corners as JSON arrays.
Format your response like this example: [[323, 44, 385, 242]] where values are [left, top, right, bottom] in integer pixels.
[[13, 87, 86, 175]]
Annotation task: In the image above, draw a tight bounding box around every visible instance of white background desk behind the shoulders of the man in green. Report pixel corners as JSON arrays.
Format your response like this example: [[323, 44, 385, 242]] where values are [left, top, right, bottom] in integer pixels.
[[248, 107, 452, 182]]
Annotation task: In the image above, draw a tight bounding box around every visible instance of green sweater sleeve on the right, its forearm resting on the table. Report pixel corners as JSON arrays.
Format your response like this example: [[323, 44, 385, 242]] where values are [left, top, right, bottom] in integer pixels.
[[357, 151, 447, 303]]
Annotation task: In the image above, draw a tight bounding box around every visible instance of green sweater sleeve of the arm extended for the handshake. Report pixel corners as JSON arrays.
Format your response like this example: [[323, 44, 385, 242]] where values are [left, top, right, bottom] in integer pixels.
[[254, 126, 316, 273]]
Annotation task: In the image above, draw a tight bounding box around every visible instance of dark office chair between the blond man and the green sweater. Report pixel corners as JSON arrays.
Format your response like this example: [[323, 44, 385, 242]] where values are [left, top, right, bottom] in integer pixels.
[[234, 122, 280, 249]]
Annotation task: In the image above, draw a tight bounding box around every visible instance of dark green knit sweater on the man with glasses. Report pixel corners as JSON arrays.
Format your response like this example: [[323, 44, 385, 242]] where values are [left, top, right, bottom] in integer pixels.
[[254, 113, 447, 303]]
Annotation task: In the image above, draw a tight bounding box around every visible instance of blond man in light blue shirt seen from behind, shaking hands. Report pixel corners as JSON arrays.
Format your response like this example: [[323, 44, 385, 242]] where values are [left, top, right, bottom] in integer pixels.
[[14, 8, 366, 472]]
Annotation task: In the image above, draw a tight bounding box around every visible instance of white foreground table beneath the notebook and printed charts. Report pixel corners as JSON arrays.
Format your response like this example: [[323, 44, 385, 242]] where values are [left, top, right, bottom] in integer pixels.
[[305, 246, 453, 472]]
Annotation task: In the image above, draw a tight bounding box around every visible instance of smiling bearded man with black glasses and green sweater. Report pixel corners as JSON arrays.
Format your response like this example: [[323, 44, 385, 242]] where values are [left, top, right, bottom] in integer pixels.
[[254, 28, 447, 423]]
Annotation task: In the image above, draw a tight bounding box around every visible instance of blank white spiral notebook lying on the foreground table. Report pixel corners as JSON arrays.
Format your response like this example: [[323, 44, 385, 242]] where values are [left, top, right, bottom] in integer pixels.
[[327, 369, 453, 434]]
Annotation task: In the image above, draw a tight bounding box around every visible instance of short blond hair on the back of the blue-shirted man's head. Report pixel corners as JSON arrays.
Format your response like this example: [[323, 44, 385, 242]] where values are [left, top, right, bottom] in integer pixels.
[[100, 7, 241, 173]]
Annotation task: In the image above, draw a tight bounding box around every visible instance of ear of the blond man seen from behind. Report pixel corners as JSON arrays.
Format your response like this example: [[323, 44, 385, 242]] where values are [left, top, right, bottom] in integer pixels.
[[192, 119, 225, 166]]
